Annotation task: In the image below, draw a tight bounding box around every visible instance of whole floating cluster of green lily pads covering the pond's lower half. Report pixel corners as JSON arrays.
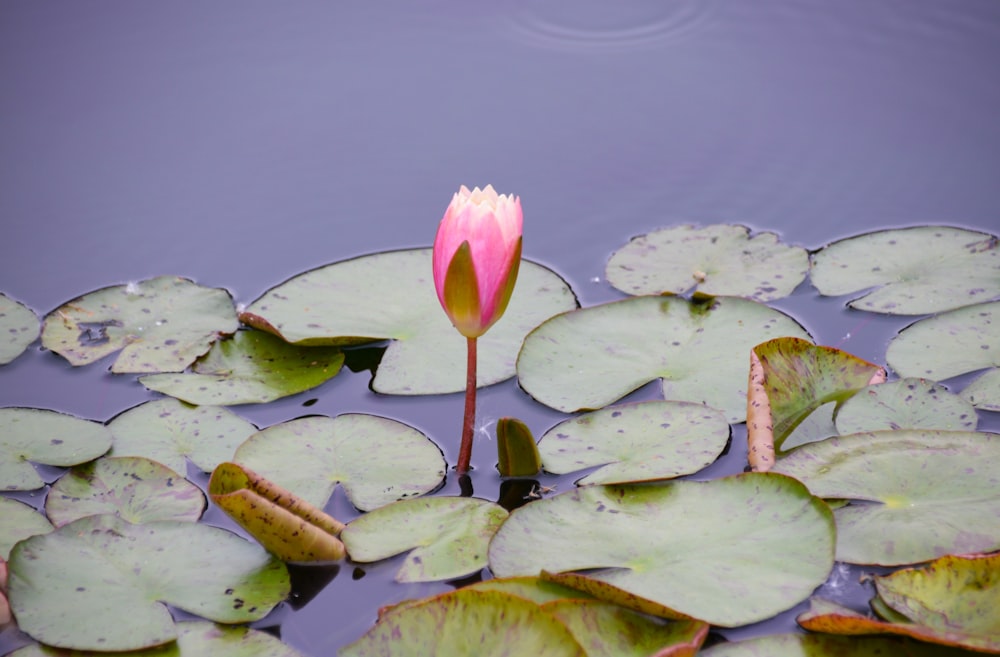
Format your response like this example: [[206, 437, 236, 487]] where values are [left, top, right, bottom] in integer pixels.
[[0, 225, 1000, 657]]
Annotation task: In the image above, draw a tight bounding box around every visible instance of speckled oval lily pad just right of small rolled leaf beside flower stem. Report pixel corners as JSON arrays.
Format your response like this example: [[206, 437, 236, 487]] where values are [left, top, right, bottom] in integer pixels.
[[538, 401, 729, 486]]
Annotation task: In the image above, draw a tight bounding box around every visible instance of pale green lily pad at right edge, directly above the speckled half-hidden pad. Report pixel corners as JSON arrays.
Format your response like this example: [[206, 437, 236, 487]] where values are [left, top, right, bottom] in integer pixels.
[[885, 301, 1000, 409]]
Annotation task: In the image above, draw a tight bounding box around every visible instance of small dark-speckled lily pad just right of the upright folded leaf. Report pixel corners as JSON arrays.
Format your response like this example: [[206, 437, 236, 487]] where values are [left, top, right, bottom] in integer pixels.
[[836, 379, 979, 434]]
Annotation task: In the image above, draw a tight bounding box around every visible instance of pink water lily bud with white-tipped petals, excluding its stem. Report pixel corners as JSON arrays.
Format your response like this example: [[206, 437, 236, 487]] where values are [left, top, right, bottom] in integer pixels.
[[434, 185, 522, 338]]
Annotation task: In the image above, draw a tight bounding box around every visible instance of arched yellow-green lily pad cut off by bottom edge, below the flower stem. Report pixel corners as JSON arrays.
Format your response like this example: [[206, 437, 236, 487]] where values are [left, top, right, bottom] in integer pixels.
[[339, 589, 587, 657]]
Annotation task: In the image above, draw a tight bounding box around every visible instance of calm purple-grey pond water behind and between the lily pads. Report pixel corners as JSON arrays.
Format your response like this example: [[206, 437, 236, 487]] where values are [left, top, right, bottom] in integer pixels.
[[0, 0, 1000, 656]]
